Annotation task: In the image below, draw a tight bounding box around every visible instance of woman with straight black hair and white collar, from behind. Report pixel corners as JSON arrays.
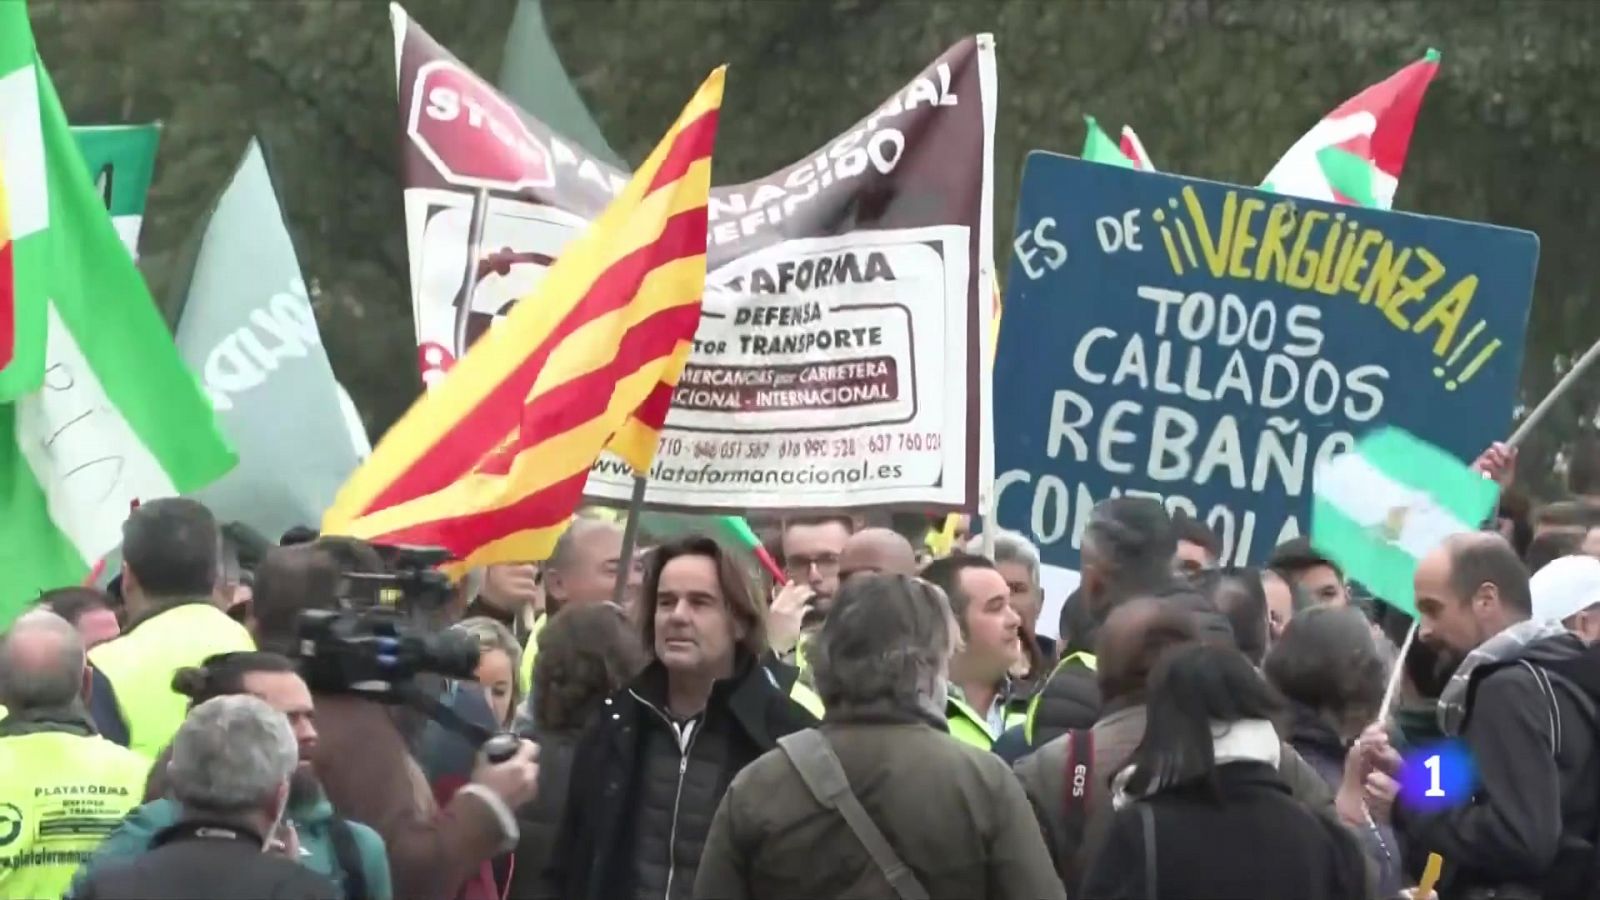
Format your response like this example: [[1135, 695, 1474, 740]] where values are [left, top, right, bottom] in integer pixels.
[[1083, 644, 1371, 900]]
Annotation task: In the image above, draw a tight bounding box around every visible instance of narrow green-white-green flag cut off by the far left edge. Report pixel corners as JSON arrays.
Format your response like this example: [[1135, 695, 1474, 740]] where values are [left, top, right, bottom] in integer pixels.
[[0, 2, 49, 393]]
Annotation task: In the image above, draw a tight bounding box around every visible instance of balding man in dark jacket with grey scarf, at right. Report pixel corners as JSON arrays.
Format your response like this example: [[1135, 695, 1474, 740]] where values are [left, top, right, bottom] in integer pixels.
[[1363, 533, 1600, 898]]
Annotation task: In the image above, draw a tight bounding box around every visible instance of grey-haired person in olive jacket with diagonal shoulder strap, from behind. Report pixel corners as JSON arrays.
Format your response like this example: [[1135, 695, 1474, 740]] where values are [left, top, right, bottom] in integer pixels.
[[694, 575, 1066, 900]]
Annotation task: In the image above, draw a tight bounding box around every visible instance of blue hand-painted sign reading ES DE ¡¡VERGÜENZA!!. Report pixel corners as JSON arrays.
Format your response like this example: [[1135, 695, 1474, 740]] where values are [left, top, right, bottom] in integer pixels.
[[994, 152, 1539, 567]]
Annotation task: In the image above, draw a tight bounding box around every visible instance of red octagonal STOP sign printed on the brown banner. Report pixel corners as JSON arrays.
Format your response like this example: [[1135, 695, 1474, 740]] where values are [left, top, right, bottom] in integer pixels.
[[406, 59, 555, 191]]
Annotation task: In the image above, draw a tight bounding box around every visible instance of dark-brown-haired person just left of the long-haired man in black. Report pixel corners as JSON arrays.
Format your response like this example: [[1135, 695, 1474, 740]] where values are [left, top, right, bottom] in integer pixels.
[[507, 604, 645, 898]]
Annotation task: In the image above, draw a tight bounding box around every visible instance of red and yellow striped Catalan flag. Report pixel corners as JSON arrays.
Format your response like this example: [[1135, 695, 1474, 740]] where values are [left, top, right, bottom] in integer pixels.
[[323, 69, 725, 565]]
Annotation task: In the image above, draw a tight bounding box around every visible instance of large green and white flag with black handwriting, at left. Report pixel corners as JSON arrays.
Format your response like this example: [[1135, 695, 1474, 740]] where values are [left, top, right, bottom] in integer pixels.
[[0, 3, 237, 628]]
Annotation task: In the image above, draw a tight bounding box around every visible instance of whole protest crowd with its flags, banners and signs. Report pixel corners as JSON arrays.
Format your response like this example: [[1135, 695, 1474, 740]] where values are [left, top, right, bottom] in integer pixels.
[[0, 3, 1600, 900]]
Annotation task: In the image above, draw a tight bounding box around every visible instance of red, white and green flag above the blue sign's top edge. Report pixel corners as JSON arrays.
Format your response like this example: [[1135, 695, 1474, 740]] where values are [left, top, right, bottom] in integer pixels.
[[1261, 50, 1438, 210]]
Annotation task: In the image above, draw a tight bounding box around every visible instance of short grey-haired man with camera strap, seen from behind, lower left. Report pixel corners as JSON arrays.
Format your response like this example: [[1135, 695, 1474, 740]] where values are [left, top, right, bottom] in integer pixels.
[[72, 695, 339, 900]]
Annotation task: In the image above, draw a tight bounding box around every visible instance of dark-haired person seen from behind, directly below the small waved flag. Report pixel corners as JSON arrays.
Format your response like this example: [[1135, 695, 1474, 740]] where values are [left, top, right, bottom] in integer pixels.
[[1262, 607, 1403, 897]]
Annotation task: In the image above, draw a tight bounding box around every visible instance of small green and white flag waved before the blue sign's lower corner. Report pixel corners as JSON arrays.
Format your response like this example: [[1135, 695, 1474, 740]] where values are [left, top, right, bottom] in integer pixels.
[[1310, 428, 1499, 618]]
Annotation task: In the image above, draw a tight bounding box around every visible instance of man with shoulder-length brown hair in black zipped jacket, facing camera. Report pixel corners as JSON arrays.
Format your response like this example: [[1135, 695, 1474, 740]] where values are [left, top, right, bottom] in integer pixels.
[[539, 536, 816, 900]]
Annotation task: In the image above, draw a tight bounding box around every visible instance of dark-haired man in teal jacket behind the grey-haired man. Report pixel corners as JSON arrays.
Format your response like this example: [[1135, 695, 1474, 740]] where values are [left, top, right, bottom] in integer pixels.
[[69, 650, 394, 900]]
